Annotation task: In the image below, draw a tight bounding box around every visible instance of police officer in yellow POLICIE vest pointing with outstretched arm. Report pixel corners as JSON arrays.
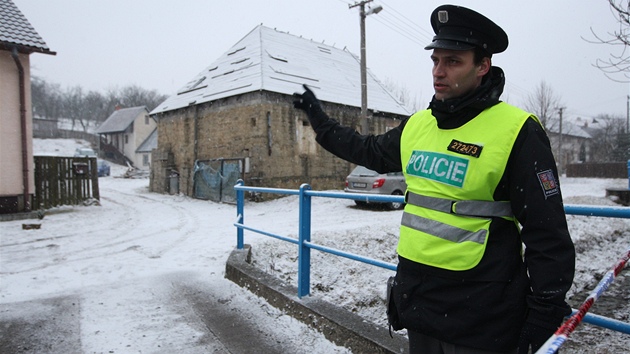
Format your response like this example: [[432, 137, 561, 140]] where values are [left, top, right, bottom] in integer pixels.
[[294, 5, 575, 353]]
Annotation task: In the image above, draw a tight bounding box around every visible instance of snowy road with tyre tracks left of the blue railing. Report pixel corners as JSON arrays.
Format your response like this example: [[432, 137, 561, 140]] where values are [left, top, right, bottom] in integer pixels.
[[0, 177, 347, 353]]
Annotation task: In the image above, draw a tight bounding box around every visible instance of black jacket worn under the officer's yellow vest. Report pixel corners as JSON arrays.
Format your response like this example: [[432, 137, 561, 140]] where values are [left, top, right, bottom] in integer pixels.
[[308, 67, 575, 351]]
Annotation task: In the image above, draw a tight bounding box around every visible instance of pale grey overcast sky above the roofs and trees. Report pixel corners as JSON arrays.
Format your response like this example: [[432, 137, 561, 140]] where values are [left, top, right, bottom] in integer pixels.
[[13, 0, 630, 118]]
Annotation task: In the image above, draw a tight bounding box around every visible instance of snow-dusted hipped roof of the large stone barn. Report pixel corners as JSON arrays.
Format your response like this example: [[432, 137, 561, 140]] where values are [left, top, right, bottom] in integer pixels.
[[151, 25, 410, 116]]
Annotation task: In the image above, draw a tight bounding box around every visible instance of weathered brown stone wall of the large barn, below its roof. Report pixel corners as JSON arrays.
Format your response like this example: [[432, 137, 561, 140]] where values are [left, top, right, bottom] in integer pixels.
[[151, 91, 402, 195]]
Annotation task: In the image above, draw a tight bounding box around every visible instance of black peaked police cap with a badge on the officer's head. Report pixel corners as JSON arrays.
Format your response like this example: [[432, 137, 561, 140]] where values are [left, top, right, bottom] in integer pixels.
[[424, 5, 508, 54]]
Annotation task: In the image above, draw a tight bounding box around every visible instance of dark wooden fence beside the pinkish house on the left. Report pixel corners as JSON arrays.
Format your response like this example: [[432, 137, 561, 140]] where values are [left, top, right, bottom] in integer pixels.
[[33, 156, 100, 210]]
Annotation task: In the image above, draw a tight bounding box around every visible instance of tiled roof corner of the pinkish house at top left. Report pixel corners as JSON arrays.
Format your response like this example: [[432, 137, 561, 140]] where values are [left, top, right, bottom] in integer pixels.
[[0, 0, 56, 55]]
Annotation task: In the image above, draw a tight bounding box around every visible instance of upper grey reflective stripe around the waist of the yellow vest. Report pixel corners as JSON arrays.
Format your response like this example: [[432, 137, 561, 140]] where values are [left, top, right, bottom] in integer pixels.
[[405, 192, 514, 218]]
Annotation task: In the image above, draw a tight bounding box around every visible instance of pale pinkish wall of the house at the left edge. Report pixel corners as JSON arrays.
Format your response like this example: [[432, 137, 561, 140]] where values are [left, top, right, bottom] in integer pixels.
[[0, 50, 35, 211]]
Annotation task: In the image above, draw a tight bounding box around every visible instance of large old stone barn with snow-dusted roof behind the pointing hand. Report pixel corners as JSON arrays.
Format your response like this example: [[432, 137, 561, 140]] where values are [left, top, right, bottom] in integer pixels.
[[151, 25, 410, 201]]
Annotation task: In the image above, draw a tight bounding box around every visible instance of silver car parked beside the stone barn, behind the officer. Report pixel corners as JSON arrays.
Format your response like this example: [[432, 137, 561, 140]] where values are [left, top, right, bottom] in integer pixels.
[[344, 166, 407, 210]]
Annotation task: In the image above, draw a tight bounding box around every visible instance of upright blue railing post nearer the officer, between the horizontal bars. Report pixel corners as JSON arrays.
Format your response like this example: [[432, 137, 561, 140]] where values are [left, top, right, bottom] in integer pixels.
[[298, 183, 311, 298]]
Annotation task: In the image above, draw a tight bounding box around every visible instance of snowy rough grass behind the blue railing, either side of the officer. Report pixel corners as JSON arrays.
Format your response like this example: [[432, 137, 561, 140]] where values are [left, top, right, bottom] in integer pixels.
[[252, 178, 630, 354]]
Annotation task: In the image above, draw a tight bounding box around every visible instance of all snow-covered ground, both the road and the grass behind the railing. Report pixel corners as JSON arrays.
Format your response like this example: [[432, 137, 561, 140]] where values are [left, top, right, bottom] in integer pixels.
[[0, 139, 630, 353]]
